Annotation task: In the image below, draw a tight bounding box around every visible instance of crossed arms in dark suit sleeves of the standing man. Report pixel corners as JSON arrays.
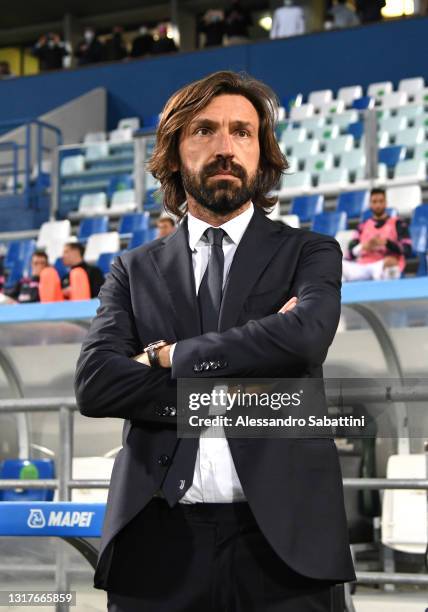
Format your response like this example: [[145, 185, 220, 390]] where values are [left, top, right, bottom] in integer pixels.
[[75, 237, 341, 423]]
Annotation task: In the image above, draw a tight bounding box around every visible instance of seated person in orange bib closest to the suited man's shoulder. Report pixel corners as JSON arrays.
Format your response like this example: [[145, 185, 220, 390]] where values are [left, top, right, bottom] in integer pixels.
[[62, 242, 104, 300]]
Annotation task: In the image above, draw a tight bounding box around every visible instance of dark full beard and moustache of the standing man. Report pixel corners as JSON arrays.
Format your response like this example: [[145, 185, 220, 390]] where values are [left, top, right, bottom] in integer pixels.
[[180, 159, 259, 214]]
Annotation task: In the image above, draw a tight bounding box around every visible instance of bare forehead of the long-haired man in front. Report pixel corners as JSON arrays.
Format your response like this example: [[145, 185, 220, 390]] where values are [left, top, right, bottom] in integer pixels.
[[192, 94, 259, 125]]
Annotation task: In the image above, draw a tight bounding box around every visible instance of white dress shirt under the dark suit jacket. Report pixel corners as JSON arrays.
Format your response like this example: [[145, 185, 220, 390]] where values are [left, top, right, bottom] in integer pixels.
[[170, 203, 254, 504]]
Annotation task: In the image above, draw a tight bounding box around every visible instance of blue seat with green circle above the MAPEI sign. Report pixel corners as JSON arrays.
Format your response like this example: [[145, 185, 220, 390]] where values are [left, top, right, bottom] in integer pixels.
[[0, 459, 55, 502]]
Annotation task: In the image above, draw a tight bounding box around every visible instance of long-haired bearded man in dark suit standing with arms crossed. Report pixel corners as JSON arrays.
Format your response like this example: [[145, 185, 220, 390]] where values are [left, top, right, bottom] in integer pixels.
[[75, 72, 355, 612]]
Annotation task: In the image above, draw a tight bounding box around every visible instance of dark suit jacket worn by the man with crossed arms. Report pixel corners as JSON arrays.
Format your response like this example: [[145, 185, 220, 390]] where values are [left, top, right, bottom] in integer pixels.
[[75, 209, 355, 590]]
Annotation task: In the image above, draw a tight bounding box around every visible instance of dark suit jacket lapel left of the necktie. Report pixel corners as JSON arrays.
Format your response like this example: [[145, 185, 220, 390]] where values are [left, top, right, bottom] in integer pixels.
[[150, 218, 201, 340]]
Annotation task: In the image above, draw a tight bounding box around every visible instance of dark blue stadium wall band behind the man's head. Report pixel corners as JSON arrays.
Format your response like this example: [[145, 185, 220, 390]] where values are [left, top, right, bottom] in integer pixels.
[[0, 17, 428, 129]]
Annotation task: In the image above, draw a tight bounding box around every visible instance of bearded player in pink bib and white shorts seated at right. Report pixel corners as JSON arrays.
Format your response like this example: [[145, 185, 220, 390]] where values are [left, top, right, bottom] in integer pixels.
[[343, 189, 412, 281]]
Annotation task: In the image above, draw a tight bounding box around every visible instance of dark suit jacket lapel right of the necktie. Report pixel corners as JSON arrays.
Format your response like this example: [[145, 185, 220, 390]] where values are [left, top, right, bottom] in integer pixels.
[[219, 208, 287, 331]]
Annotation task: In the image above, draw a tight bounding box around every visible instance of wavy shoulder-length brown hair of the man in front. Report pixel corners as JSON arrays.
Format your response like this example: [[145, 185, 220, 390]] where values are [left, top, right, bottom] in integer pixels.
[[148, 70, 288, 218]]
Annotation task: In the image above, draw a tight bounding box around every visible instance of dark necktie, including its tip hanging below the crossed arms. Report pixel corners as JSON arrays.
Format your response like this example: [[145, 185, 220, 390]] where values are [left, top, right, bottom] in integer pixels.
[[162, 227, 225, 507]]
